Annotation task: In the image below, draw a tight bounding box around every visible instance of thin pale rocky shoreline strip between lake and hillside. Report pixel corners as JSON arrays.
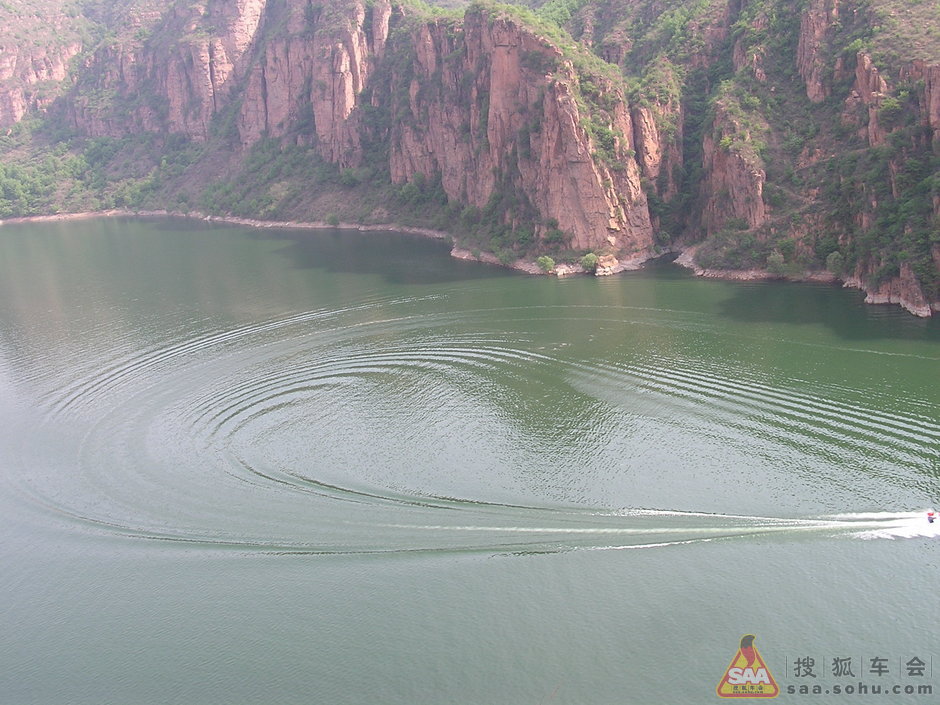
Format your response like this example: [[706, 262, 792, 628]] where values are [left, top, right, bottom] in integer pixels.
[[0, 209, 940, 318]]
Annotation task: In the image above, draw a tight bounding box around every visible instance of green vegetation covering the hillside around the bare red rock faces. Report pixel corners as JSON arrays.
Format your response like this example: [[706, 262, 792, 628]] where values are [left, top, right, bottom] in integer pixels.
[[0, 0, 940, 298]]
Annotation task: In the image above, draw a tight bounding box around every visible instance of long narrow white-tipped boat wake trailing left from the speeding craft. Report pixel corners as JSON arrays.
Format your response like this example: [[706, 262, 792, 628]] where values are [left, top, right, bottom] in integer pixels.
[[12, 479, 940, 555]]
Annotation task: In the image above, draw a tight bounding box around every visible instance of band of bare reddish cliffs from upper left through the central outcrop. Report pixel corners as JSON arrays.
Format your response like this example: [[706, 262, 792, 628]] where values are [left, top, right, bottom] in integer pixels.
[[58, 0, 652, 256]]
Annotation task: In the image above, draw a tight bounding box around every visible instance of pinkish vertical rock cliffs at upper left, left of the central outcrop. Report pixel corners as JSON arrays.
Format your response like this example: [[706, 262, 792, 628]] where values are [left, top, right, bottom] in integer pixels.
[[71, 0, 392, 158]]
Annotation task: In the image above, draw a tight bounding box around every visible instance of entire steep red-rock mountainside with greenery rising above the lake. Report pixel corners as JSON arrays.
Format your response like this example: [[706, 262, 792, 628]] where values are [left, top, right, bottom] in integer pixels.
[[0, 0, 940, 315]]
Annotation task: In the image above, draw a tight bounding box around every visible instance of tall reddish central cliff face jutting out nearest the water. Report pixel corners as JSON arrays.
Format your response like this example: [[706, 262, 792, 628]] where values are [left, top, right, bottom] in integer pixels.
[[390, 12, 652, 252]]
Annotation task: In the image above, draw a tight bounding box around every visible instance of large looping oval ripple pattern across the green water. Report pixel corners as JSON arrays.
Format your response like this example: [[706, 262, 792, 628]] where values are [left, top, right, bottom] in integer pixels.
[[14, 299, 938, 553]]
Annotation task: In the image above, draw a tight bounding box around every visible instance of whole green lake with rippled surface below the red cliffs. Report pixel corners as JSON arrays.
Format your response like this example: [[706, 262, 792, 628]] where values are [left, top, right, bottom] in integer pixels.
[[0, 219, 940, 705]]
